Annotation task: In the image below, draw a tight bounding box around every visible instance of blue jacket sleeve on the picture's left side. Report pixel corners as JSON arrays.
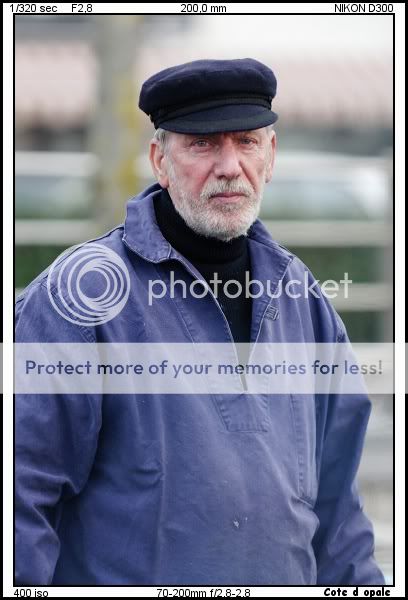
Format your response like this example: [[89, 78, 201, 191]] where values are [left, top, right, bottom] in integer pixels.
[[14, 283, 101, 585]]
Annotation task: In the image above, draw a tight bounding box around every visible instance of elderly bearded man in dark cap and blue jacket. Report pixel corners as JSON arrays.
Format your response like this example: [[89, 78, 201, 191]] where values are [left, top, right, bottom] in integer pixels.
[[16, 59, 384, 585]]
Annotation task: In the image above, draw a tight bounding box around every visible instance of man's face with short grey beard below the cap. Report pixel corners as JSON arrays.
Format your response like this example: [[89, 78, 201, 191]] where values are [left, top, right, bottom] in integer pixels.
[[150, 128, 276, 241]]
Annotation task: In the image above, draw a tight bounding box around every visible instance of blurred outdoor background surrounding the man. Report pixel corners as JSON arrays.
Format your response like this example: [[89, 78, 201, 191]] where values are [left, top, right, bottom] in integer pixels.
[[15, 14, 393, 583]]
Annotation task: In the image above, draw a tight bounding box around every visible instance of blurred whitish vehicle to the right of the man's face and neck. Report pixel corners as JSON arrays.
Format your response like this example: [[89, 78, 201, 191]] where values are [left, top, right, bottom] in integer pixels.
[[262, 152, 390, 220]]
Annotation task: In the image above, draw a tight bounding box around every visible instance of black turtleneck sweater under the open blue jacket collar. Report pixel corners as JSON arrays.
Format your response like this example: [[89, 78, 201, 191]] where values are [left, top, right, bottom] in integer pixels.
[[154, 190, 252, 354]]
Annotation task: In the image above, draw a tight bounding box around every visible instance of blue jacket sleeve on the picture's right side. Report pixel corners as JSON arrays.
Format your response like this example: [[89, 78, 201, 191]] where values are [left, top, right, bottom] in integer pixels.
[[313, 333, 385, 585]]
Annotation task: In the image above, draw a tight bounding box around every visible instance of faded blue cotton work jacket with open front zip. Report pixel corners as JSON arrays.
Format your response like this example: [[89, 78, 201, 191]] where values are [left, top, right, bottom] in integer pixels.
[[15, 184, 384, 585]]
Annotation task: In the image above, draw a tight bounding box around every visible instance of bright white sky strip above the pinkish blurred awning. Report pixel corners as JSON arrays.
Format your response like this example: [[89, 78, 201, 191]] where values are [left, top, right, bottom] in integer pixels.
[[164, 14, 393, 57]]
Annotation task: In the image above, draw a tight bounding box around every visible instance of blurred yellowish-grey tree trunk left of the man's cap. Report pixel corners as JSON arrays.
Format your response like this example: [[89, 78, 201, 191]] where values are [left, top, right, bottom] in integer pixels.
[[90, 15, 143, 228]]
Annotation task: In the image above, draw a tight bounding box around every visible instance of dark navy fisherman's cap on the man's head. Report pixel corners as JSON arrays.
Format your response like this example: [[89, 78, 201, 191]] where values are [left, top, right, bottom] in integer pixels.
[[139, 58, 278, 133]]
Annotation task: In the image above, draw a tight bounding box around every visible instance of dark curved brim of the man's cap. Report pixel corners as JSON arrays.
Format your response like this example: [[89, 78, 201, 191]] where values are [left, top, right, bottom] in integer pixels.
[[159, 104, 278, 133]]
